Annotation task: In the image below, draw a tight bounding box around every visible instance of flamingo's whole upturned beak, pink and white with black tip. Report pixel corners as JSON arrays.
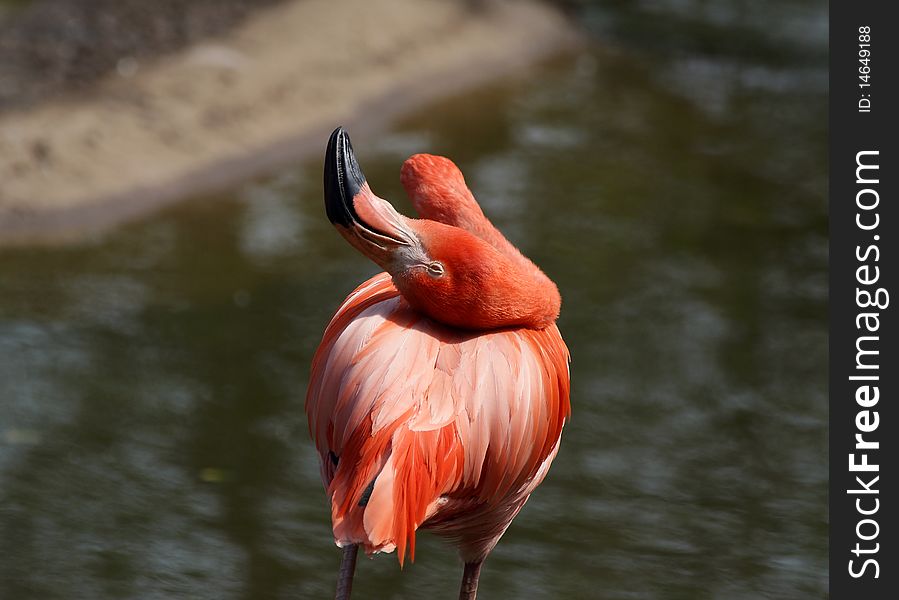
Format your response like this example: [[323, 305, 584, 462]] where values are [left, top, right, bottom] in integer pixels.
[[324, 127, 420, 270]]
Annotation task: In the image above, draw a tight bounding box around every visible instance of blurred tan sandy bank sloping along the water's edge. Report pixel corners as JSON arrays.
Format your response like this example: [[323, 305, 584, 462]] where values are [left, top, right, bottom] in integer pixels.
[[0, 0, 578, 243]]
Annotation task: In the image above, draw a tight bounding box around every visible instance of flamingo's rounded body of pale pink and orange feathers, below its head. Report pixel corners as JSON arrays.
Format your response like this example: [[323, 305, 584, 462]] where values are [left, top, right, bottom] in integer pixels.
[[306, 273, 570, 563]]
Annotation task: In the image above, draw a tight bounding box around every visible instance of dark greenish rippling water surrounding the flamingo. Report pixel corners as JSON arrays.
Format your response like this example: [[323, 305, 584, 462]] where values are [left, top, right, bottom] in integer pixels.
[[0, 0, 827, 599]]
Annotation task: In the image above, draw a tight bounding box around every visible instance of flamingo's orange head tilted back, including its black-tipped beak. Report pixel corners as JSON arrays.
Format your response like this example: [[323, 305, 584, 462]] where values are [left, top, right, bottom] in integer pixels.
[[324, 127, 561, 330]]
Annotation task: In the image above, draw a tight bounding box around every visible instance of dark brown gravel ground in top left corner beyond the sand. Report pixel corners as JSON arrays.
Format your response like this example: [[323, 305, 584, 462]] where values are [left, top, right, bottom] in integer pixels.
[[0, 0, 281, 110]]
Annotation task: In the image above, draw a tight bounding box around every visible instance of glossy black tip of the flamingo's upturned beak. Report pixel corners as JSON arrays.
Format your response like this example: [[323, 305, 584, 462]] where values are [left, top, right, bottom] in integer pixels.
[[324, 127, 365, 227]]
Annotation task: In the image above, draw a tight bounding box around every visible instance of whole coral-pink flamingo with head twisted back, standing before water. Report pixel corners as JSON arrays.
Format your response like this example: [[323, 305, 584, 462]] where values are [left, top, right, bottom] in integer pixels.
[[306, 127, 570, 600]]
